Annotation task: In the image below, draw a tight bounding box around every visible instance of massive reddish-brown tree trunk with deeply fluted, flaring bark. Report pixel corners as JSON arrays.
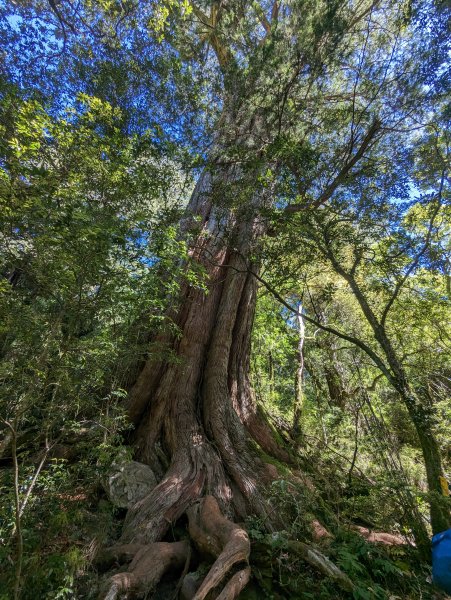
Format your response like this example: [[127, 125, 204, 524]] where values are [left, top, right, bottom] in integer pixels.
[[99, 164, 290, 598]]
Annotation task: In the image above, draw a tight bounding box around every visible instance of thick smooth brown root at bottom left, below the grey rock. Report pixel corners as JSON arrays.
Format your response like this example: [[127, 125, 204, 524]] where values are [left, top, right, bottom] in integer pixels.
[[101, 541, 190, 600]]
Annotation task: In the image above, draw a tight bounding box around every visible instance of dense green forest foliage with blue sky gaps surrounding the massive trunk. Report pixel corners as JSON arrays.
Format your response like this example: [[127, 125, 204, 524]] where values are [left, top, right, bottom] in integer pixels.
[[0, 0, 451, 600]]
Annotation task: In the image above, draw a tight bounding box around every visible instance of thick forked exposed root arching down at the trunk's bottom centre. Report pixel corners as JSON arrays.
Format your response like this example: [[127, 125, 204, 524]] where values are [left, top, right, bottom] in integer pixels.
[[187, 496, 250, 600]]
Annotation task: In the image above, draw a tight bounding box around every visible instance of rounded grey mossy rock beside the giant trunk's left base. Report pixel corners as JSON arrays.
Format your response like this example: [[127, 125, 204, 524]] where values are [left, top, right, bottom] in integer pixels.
[[104, 461, 157, 508]]
